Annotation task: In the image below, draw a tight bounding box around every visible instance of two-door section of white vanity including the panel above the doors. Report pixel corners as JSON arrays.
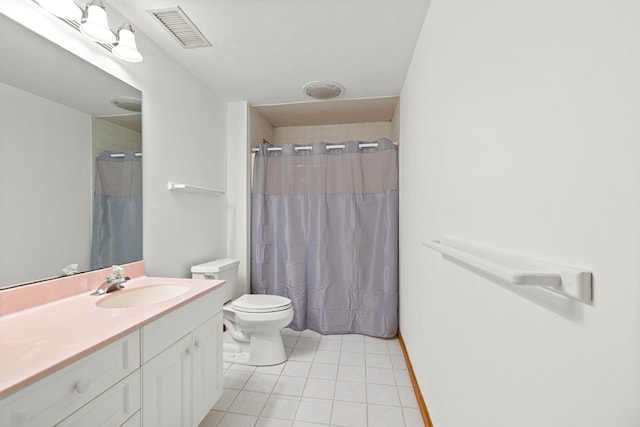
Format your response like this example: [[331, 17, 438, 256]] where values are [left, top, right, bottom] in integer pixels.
[[141, 292, 222, 427]]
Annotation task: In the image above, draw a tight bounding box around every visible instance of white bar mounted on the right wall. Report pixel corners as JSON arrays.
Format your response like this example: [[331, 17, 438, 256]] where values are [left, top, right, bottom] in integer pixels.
[[422, 238, 592, 302]]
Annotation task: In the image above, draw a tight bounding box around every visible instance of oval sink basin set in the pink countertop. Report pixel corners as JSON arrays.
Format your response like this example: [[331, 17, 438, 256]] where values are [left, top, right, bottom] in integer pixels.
[[96, 283, 189, 308]]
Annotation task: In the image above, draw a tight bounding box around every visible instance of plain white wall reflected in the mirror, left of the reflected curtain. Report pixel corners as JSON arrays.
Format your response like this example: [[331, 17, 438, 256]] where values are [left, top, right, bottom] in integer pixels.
[[0, 83, 93, 287]]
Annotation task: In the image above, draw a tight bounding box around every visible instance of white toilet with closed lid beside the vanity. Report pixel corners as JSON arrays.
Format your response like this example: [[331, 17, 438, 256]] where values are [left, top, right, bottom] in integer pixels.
[[191, 258, 293, 366]]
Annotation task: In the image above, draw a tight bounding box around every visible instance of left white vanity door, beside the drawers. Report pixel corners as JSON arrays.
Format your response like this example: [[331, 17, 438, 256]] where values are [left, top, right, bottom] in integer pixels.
[[142, 334, 192, 427]]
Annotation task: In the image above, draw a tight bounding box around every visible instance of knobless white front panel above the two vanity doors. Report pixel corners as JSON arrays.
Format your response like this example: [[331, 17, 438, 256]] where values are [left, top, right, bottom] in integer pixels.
[[140, 285, 224, 364]]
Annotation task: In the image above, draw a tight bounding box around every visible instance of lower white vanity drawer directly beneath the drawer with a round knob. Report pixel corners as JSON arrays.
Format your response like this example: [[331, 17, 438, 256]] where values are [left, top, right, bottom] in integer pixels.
[[58, 369, 140, 427]]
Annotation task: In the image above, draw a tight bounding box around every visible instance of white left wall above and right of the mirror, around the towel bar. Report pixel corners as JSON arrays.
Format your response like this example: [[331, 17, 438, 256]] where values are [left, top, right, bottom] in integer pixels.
[[0, 0, 227, 277]]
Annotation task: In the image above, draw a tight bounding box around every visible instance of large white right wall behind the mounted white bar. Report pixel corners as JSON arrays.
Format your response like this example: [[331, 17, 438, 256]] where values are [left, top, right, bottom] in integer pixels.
[[400, 0, 640, 427]]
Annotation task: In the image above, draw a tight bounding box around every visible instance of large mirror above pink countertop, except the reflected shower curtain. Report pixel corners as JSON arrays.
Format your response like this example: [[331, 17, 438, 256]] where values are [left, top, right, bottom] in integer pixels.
[[0, 14, 142, 288]]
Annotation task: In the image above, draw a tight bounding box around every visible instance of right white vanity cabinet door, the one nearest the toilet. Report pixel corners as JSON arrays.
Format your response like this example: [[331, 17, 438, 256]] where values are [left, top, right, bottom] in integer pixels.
[[192, 313, 222, 425]]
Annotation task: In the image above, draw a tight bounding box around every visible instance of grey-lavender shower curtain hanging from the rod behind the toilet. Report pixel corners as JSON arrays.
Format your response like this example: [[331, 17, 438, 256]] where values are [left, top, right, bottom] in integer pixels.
[[251, 139, 398, 338]]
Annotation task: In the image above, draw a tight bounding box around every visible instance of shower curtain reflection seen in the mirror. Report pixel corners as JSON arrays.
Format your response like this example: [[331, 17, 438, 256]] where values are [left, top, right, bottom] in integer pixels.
[[91, 151, 142, 269]]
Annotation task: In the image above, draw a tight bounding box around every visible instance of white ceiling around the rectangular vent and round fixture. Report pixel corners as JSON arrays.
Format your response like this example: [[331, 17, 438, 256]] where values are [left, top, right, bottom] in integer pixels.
[[108, 0, 429, 105]]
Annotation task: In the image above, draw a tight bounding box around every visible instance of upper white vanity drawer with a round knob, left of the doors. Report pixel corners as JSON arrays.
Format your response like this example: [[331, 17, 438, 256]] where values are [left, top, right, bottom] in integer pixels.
[[0, 331, 140, 427]]
